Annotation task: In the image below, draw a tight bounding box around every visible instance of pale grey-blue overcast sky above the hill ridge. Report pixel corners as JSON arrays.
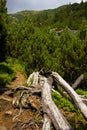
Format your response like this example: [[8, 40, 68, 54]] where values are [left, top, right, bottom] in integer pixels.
[[7, 0, 81, 13]]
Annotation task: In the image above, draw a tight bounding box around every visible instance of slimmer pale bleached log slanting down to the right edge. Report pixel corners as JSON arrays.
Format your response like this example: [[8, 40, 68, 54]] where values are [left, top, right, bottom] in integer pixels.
[[52, 72, 87, 120]]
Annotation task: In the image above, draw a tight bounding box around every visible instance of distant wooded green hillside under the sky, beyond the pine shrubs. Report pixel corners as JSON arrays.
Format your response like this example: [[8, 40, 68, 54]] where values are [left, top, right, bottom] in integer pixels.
[[9, 2, 87, 29]]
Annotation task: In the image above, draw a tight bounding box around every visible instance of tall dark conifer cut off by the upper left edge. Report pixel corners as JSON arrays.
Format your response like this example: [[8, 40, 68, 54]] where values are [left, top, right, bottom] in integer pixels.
[[0, 0, 7, 62]]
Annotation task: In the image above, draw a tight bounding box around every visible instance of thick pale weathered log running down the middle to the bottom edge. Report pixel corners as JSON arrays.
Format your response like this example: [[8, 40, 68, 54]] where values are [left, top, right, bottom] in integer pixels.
[[42, 77, 73, 130]]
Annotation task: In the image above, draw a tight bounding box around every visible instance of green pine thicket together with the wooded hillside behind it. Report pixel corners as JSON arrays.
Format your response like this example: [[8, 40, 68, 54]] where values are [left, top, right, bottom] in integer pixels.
[[7, 2, 87, 84]]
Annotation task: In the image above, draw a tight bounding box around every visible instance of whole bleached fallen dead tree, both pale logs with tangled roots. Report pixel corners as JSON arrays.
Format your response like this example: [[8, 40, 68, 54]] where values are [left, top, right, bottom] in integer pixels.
[[11, 72, 87, 130]]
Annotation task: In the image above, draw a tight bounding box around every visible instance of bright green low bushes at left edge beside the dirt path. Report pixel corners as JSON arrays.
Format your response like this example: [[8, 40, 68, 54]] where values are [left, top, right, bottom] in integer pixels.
[[0, 58, 25, 87]]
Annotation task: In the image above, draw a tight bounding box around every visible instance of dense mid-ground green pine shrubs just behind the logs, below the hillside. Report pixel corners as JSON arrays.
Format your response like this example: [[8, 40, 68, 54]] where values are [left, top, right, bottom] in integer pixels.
[[8, 13, 87, 83]]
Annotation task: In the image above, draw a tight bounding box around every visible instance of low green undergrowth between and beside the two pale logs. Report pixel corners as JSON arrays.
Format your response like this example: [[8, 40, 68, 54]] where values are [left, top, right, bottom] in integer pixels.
[[52, 89, 87, 130]]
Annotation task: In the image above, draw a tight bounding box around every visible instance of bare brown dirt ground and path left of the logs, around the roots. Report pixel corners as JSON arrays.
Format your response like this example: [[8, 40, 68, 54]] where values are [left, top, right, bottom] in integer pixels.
[[0, 72, 42, 130]]
